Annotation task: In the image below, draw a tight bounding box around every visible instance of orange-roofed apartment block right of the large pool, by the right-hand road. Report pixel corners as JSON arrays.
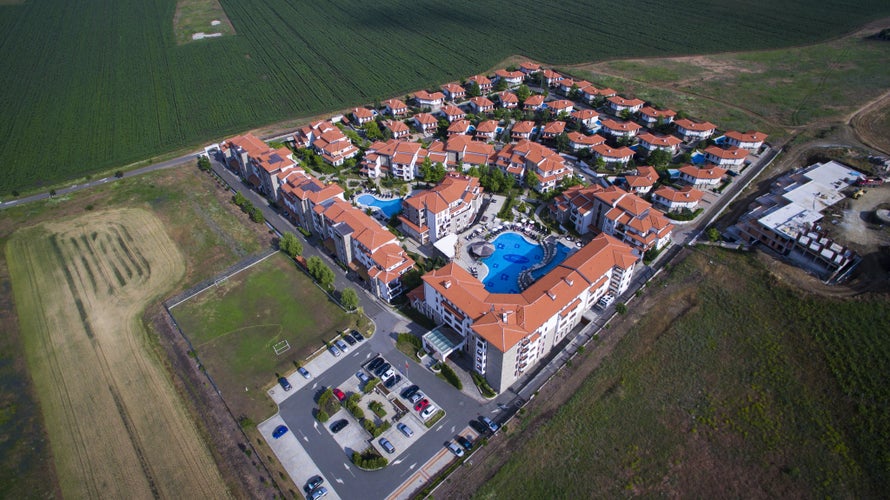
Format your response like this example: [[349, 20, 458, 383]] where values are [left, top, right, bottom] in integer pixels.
[[550, 185, 674, 255]]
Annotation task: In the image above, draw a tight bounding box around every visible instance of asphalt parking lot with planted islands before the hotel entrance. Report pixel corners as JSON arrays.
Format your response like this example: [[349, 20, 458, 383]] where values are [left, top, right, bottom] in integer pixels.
[[259, 328, 499, 498]]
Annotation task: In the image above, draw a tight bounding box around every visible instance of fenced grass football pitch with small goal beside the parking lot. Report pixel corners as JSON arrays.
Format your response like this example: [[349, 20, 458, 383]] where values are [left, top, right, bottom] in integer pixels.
[[171, 253, 351, 421]]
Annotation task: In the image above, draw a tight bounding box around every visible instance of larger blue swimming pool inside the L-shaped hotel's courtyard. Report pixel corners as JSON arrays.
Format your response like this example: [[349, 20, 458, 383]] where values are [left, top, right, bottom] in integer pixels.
[[482, 233, 571, 293]]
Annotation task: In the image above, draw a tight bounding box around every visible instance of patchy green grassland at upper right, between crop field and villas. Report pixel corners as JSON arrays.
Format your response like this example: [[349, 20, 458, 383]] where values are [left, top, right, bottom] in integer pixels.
[[569, 33, 890, 139]]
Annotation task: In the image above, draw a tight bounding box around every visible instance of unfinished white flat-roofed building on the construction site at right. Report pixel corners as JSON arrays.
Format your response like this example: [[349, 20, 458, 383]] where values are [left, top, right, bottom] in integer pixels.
[[734, 161, 862, 280]]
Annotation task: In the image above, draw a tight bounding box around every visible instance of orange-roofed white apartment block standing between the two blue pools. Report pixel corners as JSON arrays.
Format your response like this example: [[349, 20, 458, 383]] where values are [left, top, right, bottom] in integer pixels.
[[399, 172, 482, 245]]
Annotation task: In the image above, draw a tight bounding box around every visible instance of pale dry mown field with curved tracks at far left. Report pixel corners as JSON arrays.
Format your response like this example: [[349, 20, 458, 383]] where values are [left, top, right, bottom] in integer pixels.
[[6, 209, 229, 498]]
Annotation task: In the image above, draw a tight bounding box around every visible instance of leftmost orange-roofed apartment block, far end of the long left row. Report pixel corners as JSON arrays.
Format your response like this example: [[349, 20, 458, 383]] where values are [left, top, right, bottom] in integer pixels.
[[219, 134, 297, 201]]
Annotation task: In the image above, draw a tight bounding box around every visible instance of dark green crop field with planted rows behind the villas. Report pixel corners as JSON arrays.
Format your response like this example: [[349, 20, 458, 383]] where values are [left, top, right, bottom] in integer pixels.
[[0, 0, 890, 196]]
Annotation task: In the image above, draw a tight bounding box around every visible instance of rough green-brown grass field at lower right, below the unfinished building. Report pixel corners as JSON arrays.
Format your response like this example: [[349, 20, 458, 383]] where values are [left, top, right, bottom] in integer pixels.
[[478, 249, 890, 498]]
